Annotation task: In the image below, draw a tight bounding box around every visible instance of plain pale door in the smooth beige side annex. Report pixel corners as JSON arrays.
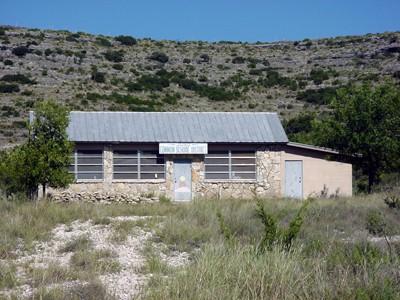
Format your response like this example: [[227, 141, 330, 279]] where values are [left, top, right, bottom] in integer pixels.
[[285, 160, 303, 199]]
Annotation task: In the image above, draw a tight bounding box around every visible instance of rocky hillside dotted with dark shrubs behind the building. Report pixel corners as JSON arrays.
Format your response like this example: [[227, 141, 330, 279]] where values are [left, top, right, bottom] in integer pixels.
[[0, 26, 400, 148]]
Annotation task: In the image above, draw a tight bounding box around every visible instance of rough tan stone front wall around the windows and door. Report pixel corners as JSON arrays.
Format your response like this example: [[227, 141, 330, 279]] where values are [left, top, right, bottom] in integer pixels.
[[49, 146, 281, 203]]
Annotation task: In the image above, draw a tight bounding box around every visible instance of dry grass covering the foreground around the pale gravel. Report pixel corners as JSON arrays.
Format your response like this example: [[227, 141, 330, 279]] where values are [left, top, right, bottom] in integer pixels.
[[0, 194, 400, 299]]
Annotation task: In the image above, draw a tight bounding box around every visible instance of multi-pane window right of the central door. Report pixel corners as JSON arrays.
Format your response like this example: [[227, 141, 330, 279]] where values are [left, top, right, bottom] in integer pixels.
[[204, 150, 256, 179]]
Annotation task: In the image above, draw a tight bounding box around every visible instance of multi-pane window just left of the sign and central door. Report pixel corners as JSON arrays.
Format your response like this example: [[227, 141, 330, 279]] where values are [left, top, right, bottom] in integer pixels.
[[113, 150, 165, 180]]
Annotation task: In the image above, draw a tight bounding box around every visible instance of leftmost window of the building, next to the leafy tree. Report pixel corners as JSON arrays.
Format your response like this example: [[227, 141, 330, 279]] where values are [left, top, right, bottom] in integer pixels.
[[69, 150, 103, 180]]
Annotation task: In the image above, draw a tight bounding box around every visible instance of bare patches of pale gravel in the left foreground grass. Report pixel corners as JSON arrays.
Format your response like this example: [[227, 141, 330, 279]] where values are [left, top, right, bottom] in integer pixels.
[[0, 216, 189, 300]]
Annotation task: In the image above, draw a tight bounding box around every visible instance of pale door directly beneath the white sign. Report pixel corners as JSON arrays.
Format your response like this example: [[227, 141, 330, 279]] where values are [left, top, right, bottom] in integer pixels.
[[174, 159, 192, 201]]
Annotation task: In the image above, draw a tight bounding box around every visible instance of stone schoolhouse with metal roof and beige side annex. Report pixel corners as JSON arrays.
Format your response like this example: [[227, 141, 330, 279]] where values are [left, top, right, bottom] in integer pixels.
[[47, 112, 352, 201]]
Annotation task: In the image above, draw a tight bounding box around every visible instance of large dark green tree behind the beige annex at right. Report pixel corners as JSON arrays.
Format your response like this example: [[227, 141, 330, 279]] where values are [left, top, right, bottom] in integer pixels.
[[313, 81, 400, 193]]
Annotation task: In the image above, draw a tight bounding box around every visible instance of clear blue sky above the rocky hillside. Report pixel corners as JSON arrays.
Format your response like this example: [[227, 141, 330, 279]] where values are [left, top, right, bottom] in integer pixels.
[[0, 0, 400, 43]]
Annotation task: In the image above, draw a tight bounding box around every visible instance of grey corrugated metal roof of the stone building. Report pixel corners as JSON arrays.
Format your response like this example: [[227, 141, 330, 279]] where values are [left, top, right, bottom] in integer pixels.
[[67, 111, 288, 143]]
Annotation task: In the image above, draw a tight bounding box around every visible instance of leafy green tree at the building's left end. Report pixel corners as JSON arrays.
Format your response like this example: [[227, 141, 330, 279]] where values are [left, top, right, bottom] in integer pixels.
[[0, 100, 73, 197]]
